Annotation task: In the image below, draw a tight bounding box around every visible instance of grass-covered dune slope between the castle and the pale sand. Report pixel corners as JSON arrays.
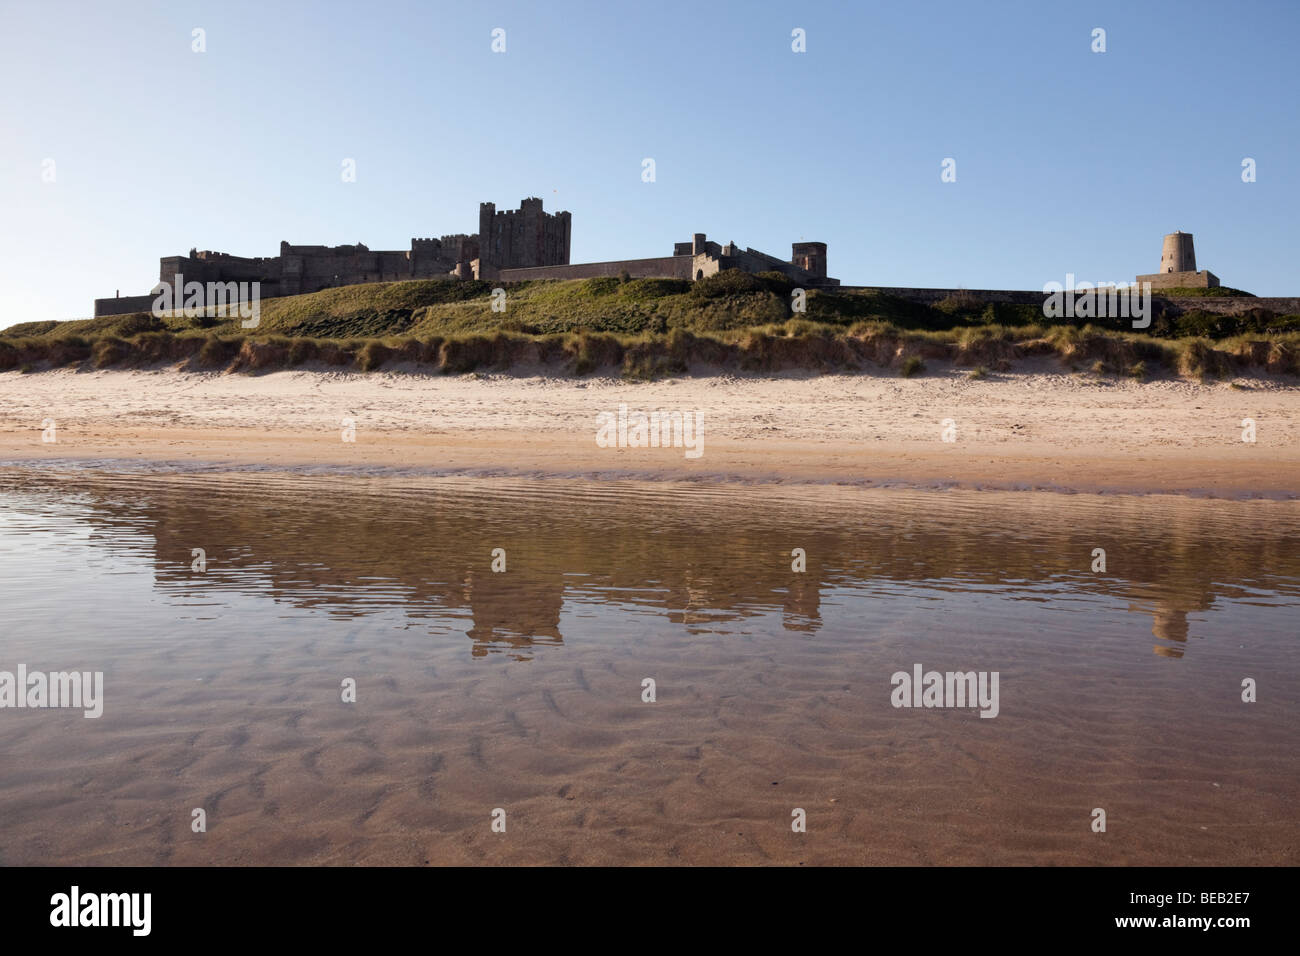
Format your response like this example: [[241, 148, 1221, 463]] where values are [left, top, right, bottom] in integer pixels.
[[0, 271, 1300, 377]]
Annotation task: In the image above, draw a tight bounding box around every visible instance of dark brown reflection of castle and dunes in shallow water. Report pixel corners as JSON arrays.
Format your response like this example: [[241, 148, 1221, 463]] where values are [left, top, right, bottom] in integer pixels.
[[0, 472, 1300, 659]]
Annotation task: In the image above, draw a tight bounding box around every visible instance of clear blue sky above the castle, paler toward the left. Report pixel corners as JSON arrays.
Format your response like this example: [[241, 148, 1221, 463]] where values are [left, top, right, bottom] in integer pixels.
[[0, 0, 1300, 328]]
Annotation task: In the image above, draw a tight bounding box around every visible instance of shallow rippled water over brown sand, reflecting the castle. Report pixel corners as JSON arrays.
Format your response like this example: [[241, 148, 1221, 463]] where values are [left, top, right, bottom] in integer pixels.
[[0, 468, 1300, 865]]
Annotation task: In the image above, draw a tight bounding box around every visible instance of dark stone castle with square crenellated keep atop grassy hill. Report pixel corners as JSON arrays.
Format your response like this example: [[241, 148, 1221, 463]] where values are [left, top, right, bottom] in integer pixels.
[[95, 198, 840, 316]]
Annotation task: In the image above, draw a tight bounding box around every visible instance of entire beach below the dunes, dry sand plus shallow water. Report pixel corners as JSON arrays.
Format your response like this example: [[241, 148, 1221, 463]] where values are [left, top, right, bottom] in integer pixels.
[[0, 363, 1300, 866]]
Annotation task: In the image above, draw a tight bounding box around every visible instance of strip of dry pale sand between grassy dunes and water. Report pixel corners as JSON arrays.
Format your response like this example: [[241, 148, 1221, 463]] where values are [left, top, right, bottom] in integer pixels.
[[0, 362, 1300, 497]]
